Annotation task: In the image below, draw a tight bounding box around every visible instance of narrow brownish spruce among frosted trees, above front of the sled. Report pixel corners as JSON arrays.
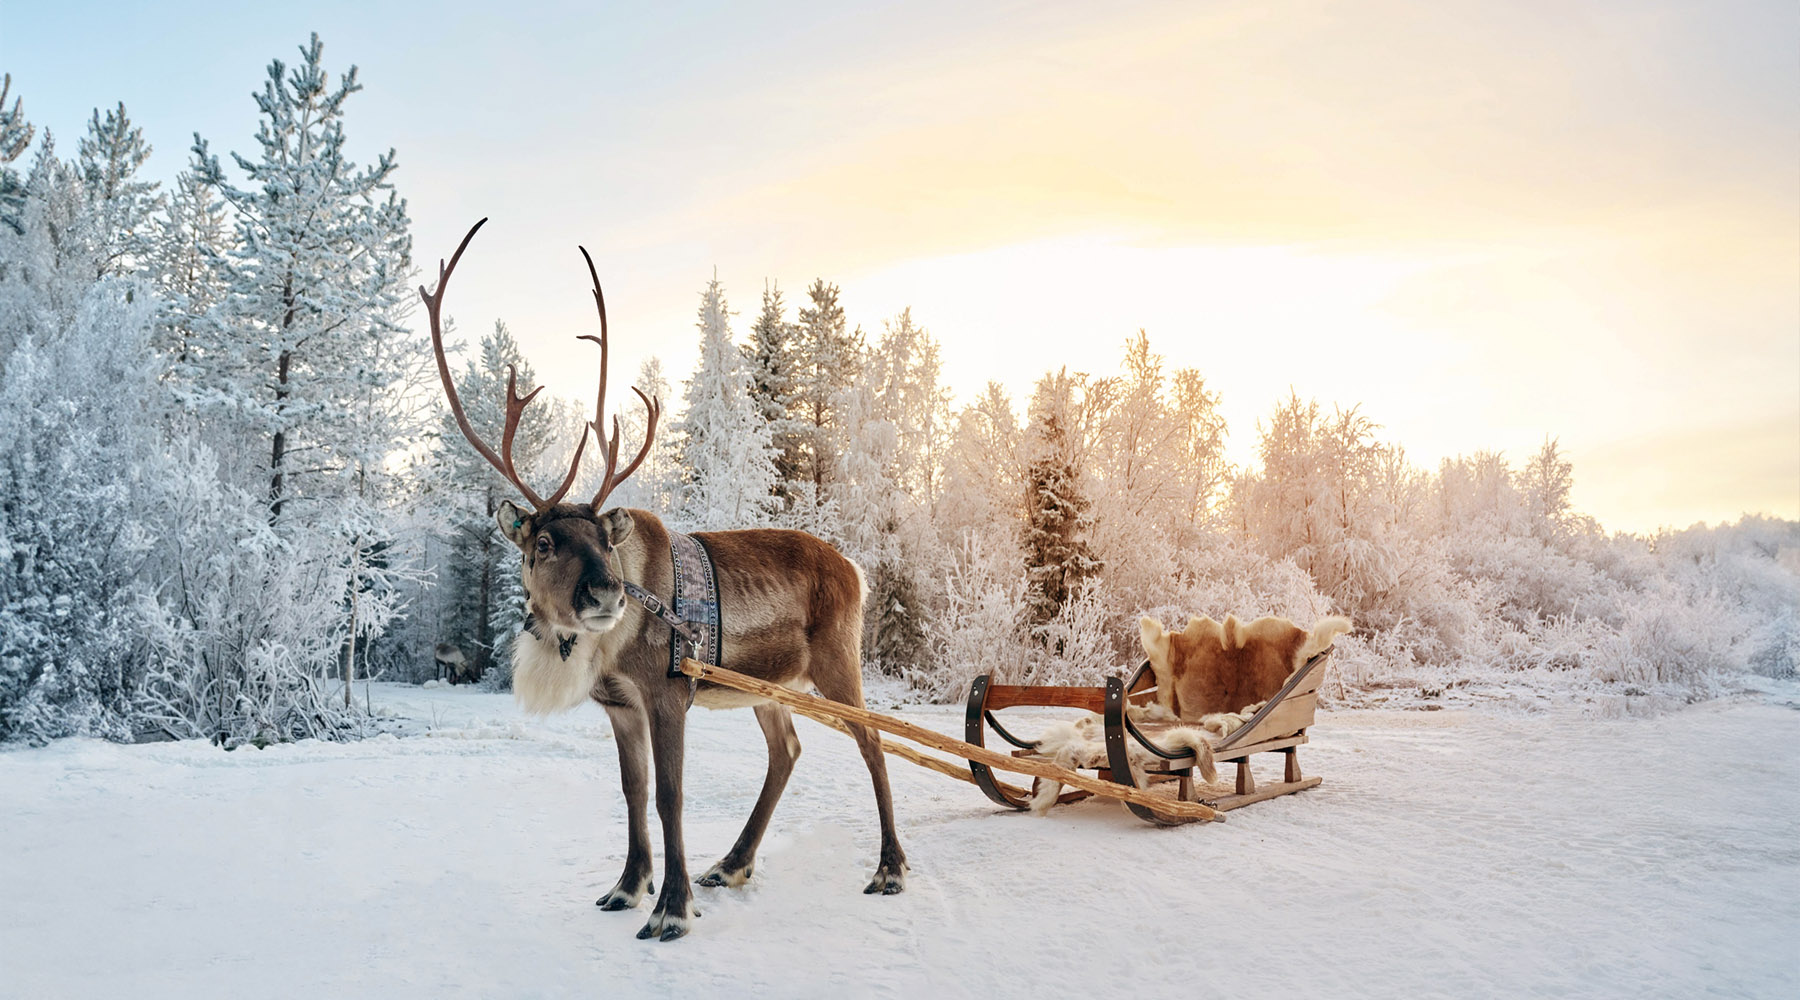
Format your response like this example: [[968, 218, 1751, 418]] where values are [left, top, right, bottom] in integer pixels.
[[1024, 371, 1103, 629]]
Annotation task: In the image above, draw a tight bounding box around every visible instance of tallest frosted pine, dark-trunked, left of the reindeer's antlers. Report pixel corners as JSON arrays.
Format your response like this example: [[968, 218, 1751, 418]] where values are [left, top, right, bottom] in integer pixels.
[[194, 34, 412, 522]]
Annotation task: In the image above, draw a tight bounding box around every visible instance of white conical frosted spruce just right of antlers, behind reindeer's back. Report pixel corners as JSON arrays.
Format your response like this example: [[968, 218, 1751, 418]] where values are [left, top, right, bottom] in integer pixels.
[[675, 269, 778, 531]]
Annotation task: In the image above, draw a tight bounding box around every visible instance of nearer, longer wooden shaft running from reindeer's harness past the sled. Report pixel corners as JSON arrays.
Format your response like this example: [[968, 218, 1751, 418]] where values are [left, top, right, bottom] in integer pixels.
[[680, 660, 1224, 822]]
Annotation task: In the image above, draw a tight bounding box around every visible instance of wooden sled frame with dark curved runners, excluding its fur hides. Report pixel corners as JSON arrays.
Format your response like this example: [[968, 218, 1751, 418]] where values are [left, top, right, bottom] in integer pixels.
[[963, 649, 1332, 826]]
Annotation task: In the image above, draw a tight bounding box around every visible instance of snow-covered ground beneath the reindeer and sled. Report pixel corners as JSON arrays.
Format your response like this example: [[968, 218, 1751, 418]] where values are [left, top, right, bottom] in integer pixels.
[[0, 685, 1800, 1000]]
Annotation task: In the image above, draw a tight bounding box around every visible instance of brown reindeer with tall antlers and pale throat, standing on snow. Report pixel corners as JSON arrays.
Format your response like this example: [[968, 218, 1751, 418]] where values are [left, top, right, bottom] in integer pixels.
[[419, 219, 907, 941]]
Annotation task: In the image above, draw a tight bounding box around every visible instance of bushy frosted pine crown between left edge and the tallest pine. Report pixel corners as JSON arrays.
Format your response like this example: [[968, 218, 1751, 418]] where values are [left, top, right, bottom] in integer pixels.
[[77, 101, 162, 277]]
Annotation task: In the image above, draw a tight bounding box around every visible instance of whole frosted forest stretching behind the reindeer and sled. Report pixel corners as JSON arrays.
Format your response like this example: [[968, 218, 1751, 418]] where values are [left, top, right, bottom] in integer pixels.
[[0, 36, 1800, 746]]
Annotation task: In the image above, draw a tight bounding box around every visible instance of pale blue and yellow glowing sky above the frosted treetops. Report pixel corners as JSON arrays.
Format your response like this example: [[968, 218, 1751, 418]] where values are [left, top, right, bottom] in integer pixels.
[[0, 0, 1800, 531]]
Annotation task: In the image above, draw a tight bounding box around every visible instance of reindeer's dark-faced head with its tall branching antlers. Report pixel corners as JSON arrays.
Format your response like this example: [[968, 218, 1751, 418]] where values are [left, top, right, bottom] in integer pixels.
[[419, 219, 662, 635]]
